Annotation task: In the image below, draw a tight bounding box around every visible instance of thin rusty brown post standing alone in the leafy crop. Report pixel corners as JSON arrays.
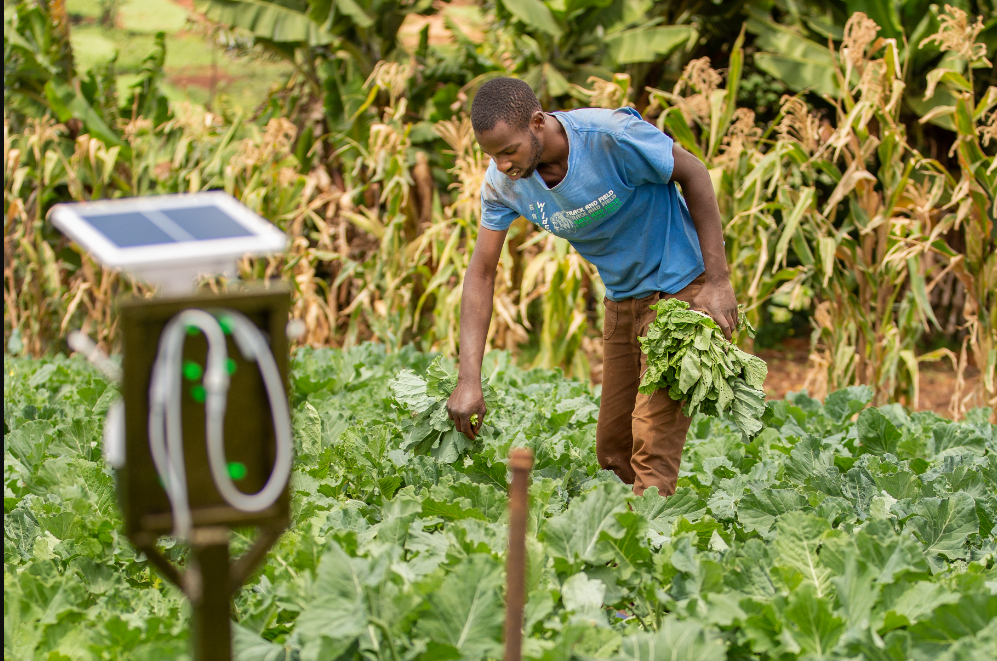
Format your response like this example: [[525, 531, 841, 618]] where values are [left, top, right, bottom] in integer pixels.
[[505, 448, 533, 661]]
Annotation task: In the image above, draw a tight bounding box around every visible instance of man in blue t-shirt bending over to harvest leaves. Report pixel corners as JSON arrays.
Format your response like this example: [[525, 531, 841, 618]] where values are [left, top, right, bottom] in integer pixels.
[[447, 78, 737, 495]]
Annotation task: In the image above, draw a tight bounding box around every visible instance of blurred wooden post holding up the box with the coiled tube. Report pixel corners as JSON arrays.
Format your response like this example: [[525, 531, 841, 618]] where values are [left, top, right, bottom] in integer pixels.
[[184, 528, 232, 661]]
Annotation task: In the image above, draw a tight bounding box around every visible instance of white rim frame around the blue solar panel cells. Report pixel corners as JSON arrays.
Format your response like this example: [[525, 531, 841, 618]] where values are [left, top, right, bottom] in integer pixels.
[[51, 192, 287, 270]]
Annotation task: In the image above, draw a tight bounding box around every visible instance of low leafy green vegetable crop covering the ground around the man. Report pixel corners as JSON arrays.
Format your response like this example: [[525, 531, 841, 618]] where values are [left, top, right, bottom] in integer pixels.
[[4, 344, 997, 661]]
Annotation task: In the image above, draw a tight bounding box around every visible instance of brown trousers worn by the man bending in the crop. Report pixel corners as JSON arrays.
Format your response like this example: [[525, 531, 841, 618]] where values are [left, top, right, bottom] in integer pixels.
[[595, 275, 706, 496]]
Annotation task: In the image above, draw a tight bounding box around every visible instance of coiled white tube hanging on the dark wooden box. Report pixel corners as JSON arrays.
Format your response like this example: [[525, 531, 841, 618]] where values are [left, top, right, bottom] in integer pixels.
[[149, 309, 293, 537]]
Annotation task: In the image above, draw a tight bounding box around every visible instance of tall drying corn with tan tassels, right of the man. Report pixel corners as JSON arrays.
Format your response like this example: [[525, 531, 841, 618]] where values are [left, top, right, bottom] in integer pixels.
[[651, 9, 997, 414]]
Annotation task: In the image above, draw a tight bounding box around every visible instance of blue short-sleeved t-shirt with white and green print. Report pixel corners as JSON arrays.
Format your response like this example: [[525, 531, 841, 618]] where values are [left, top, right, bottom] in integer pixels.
[[481, 108, 704, 301]]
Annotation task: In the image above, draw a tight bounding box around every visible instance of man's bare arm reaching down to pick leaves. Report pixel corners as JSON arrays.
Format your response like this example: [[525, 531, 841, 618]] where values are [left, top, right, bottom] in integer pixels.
[[447, 227, 506, 439]]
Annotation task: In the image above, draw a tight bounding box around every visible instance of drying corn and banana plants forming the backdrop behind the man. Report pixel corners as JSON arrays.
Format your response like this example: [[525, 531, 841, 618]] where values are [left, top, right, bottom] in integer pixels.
[[4, 0, 997, 416]]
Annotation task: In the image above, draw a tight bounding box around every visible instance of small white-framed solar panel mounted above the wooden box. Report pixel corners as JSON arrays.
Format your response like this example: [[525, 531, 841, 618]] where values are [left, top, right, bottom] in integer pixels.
[[52, 192, 287, 290]]
